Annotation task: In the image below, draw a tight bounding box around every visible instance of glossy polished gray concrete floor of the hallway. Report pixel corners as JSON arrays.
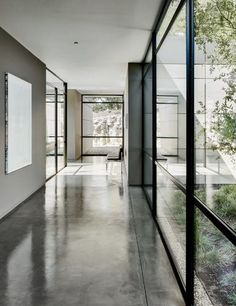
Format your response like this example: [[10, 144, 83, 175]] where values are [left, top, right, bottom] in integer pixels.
[[0, 159, 184, 306]]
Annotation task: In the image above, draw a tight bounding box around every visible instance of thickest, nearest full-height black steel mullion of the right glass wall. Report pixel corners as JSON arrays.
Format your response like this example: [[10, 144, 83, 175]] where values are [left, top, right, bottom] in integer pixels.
[[186, 0, 196, 306]]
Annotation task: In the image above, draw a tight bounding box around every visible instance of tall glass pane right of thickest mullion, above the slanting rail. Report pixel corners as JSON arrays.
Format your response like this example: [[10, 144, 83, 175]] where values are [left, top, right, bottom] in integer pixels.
[[195, 0, 236, 230]]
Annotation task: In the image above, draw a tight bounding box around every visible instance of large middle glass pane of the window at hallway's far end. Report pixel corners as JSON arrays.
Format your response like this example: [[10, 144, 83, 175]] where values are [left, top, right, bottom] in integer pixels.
[[83, 103, 123, 137]]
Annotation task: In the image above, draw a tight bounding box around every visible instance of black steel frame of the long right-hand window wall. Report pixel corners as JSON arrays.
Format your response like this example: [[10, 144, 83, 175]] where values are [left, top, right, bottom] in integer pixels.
[[142, 0, 236, 306]]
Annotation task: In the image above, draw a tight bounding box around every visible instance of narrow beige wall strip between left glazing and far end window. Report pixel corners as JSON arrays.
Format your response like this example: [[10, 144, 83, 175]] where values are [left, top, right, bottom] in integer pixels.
[[67, 89, 81, 160]]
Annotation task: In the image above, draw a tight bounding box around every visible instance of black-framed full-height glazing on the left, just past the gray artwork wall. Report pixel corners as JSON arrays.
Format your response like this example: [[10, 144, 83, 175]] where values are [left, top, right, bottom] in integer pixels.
[[46, 70, 67, 179]]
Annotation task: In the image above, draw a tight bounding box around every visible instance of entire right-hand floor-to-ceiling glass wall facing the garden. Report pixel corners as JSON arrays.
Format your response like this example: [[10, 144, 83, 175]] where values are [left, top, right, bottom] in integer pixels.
[[143, 0, 236, 306]]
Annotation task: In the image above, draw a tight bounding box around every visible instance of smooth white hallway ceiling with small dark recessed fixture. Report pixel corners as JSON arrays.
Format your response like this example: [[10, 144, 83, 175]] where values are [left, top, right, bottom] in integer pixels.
[[0, 0, 162, 93]]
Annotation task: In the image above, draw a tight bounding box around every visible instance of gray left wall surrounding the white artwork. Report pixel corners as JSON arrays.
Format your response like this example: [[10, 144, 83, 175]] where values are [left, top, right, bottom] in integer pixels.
[[0, 28, 46, 217]]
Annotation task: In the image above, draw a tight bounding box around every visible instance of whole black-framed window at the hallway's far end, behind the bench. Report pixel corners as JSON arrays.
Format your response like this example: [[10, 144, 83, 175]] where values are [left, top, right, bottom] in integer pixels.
[[82, 95, 123, 155]]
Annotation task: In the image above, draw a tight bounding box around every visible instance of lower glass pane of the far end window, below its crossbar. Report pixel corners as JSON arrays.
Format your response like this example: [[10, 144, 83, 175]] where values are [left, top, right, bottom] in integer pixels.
[[83, 137, 122, 155]]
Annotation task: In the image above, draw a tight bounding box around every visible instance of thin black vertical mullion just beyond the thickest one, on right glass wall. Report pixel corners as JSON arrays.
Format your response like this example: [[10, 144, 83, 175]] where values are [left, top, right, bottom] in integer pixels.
[[152, 32, 157, 218]]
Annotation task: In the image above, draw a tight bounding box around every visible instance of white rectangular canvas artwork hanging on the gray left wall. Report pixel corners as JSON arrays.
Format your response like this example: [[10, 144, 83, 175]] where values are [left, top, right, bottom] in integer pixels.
[[6, 73, 32, 173]]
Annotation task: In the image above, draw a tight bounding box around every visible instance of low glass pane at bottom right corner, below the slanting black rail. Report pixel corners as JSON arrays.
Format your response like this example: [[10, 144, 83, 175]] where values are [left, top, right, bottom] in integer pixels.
[[195, 209, 236, 306]]
